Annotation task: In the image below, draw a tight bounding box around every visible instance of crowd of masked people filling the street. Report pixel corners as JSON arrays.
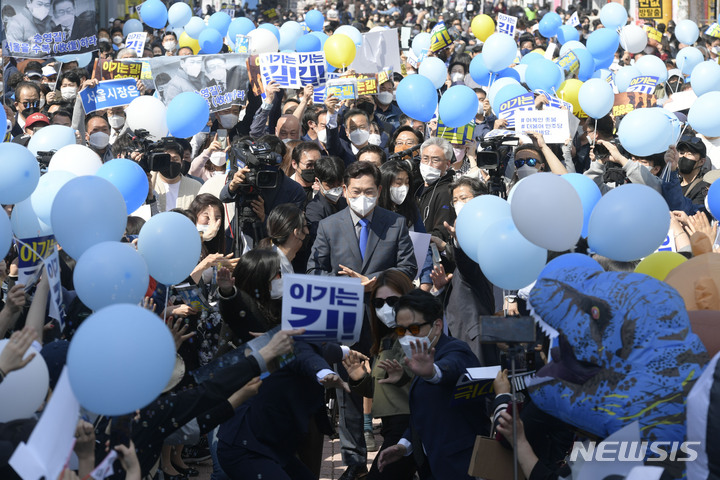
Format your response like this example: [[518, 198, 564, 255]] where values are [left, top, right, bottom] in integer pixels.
[[0, 0, 720, 480]]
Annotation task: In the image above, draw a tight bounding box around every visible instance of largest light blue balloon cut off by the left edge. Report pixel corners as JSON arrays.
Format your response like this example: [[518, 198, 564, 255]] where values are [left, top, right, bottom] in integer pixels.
[[0, 142, 40, 205]]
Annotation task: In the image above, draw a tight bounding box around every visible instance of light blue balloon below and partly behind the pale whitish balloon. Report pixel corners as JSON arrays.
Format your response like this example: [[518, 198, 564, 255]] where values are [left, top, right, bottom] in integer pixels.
[[478, 218, 547, 290]]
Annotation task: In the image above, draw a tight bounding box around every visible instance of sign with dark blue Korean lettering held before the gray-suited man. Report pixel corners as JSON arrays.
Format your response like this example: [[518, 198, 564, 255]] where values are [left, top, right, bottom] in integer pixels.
[[282, 274, 364, 345]]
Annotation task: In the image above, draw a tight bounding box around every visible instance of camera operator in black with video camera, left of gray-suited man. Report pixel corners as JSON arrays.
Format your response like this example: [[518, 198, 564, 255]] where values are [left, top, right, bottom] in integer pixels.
[[220, 140, 307, 244]]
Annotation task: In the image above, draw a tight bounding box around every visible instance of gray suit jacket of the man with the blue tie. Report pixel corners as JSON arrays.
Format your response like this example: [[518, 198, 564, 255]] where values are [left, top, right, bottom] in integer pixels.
[[308, 207, 417, 279]]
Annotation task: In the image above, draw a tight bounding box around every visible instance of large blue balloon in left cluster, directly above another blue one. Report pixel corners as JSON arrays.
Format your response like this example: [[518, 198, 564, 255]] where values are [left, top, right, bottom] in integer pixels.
[[50, 175, 127, 259]]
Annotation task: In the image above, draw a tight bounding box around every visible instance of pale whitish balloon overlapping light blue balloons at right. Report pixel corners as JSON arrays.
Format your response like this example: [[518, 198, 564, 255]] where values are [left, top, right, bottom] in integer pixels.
[[510, 173, 583, 252]]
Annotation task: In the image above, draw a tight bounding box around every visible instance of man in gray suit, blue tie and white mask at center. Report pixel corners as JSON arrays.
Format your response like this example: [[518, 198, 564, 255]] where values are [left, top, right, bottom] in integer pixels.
[[308, 162, 417, 480]]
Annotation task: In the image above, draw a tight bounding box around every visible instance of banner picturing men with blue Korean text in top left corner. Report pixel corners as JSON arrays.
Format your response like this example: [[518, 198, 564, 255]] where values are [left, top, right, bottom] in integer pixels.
[[0, 0, 97, 58]]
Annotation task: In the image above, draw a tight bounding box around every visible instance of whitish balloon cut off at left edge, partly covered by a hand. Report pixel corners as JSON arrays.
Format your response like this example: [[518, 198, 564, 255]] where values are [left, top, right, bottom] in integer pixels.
[[0, 340, 50, 422]]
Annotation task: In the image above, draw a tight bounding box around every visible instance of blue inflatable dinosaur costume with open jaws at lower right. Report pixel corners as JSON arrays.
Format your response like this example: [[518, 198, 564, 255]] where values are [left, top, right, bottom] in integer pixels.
[[529, 267, 708, 442]]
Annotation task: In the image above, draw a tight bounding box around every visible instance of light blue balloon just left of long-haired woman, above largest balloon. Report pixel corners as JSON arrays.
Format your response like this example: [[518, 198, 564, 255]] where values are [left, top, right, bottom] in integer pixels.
[[138, 212, 200, 285]]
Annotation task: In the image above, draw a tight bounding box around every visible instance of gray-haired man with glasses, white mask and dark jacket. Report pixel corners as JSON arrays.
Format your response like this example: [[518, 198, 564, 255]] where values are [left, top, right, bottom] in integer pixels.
[[415, 137, 455, 242]]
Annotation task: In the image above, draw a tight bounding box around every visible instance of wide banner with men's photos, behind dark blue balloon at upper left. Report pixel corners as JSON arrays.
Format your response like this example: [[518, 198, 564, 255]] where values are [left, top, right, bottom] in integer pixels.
[[149, 53, 248, 112]]
